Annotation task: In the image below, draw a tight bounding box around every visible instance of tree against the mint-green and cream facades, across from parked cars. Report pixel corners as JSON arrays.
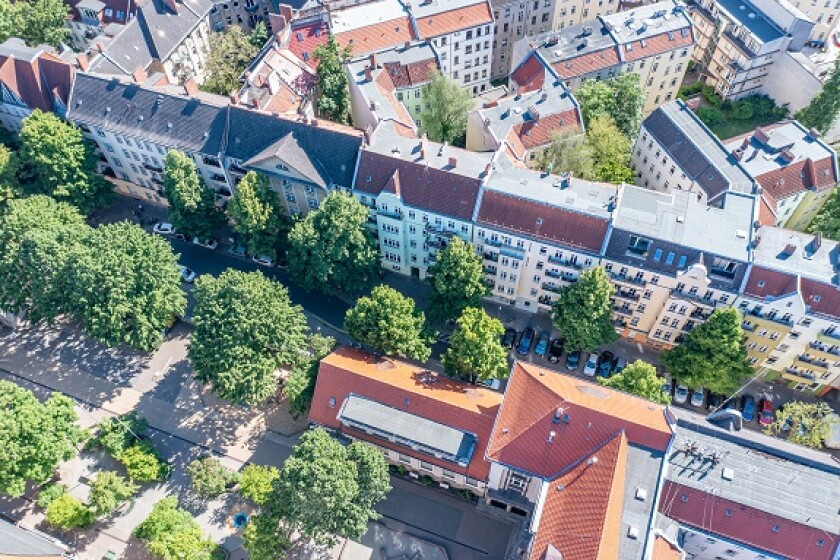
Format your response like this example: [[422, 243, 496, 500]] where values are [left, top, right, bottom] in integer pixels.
[[429, 237, 490, 319]]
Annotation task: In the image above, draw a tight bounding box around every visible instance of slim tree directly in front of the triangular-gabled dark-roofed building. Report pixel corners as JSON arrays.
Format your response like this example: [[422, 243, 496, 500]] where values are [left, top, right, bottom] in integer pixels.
[[227, 171, 284, 258]]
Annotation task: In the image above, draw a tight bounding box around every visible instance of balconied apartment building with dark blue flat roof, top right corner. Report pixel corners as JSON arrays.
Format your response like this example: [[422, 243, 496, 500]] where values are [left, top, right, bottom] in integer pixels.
[[691, 0, 814, 99]]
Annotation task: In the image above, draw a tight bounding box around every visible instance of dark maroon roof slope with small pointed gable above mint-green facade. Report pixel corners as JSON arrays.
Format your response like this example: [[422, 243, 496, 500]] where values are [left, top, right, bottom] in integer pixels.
[[355, 150, 481, 220]]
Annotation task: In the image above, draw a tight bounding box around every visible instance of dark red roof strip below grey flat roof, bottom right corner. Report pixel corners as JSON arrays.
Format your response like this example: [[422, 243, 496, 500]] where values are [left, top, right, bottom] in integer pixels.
[[659, 480, 840, 560]]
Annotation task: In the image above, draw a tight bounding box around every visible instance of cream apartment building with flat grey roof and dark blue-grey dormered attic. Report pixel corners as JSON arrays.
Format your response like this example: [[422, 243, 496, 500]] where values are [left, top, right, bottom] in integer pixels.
[[602, 186, 757, 348]]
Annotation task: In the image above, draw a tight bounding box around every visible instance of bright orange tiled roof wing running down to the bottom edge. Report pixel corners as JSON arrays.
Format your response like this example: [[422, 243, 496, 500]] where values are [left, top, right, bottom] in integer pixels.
[[528, 433, 627, 560]]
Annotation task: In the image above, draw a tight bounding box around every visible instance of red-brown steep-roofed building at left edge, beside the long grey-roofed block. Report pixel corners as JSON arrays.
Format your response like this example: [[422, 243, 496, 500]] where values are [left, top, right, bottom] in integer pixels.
[[0, 37, 76, 134]]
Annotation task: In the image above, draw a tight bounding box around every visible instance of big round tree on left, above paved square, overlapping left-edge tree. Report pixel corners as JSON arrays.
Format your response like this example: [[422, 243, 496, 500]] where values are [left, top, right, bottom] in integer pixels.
[[68, 222, 187, 350]]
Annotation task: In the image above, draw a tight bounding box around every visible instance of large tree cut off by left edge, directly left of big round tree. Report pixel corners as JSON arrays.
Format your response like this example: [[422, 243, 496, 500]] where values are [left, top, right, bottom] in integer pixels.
[[0, 195, 90, 323]]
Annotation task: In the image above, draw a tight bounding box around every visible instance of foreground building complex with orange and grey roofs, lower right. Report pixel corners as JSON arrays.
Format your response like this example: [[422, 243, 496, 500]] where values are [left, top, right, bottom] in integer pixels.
[[310, 348, 840, 560]]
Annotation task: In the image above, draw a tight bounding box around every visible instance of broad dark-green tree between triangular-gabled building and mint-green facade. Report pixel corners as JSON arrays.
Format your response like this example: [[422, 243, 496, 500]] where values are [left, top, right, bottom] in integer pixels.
[[287, 191, 379, 294]]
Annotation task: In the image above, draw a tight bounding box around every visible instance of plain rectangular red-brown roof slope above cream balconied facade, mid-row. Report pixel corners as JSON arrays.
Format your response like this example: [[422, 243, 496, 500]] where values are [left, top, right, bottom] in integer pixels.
[[477, 189, 609, 253]]
